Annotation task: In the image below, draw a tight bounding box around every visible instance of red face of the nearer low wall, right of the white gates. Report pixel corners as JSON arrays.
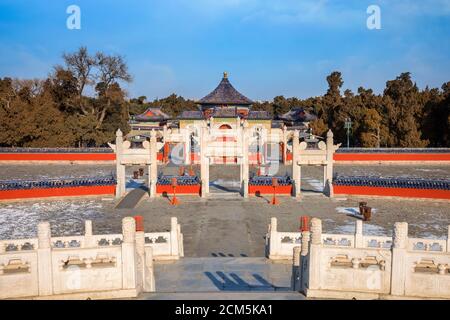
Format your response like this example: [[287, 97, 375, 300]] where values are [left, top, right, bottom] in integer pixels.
[[333, 186, 450, 200]]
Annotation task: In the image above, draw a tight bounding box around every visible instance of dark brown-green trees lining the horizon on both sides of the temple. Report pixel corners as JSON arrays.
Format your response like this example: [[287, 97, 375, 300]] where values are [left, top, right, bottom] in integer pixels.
[[0, 47, 450, 147]]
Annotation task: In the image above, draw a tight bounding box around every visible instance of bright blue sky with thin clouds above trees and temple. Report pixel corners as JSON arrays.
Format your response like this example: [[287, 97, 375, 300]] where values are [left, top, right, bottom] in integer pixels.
[[0, 0, 450, 100]]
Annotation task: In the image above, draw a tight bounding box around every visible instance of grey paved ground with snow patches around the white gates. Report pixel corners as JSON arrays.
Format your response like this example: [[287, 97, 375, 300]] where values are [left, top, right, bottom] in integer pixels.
[[0, 165, 450, 257]]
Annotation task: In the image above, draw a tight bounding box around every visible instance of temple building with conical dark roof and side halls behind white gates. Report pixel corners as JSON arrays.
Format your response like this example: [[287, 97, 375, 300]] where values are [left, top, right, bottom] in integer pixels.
[[127, 72, 315, 164]]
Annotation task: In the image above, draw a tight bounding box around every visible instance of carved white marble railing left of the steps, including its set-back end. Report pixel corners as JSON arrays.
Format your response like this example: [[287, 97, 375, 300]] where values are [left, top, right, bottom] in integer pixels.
[[0, 218, 184, 299]]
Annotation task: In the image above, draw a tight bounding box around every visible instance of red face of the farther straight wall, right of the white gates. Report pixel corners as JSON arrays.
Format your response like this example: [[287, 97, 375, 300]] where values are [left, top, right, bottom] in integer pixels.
[[333, 153, 450, 162]]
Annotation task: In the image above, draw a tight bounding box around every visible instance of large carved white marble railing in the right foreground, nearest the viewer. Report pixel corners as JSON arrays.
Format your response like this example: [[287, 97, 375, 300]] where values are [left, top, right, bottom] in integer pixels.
[[293, 218, 450, 299]]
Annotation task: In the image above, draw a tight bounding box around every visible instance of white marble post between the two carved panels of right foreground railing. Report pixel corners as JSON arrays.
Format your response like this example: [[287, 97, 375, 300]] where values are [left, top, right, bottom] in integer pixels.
[[391, 222, 408, 296]]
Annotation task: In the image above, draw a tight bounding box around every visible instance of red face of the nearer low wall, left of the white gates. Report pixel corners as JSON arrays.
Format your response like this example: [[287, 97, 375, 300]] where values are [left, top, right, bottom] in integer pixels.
[[0, 185, 116, 200]]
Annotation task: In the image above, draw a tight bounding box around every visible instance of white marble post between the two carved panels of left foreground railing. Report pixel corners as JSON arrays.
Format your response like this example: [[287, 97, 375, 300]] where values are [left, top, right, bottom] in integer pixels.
[[37, 222, 53, 296]]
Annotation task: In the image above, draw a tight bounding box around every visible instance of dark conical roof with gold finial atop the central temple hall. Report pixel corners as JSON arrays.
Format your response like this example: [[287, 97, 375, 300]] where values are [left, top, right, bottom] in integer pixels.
[[198, 72, 253, 106]]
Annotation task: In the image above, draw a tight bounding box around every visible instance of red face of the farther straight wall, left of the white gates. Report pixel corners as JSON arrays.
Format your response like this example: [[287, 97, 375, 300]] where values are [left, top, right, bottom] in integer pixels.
[[0, 153, 116, 161]]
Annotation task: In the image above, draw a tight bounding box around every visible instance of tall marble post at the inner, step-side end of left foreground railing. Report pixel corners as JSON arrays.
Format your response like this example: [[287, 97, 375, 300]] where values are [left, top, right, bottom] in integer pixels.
[[122, 217, 138, 289]]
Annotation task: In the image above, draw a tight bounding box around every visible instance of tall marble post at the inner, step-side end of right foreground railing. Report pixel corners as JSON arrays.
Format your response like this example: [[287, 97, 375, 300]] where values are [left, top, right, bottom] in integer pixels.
[[305, 218, 322, 291]]
